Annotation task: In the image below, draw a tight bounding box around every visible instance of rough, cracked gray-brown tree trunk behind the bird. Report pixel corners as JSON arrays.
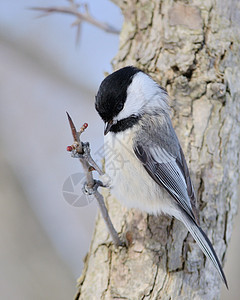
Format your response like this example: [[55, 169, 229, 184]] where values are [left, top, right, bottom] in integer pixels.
[[76, 0, 240, 300]]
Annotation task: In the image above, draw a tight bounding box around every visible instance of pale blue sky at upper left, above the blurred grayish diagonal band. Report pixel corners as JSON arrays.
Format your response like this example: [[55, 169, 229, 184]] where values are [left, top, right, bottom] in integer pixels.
[[0, 0, 123, 88]]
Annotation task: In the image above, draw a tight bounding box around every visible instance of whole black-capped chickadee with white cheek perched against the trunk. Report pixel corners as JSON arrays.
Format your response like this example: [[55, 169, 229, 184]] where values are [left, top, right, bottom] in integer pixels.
[[95, 66, 227, 286]]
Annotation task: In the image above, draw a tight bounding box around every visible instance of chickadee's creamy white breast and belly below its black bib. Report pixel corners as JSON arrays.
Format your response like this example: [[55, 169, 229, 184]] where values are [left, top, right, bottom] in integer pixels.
[[104, 125, 175, 215]]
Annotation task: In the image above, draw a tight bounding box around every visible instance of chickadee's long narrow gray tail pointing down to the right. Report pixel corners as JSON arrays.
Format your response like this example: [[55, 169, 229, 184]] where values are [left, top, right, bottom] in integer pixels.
[[181, 212, 228, 289]]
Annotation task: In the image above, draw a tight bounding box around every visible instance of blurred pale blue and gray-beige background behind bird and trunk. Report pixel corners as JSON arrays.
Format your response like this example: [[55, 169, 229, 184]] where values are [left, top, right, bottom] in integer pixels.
[[0, 0, 240, 300]]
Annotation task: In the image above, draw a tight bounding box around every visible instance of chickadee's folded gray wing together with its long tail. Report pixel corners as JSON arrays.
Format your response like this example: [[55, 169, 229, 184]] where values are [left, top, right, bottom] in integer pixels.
[[133, 134, 228, 287]]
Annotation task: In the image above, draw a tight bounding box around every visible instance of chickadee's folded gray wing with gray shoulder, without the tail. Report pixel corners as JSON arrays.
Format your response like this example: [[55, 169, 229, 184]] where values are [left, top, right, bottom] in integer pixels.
[[133, 112, 199, 223]]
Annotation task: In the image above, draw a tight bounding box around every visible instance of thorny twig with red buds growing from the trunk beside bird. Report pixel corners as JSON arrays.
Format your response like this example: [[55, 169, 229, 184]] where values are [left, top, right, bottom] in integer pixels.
[[67, 113, 124, 247]]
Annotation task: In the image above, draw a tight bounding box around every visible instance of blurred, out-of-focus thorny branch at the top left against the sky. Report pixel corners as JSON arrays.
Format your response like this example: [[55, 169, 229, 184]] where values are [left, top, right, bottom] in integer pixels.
[[30, 1, 120, 34]]
